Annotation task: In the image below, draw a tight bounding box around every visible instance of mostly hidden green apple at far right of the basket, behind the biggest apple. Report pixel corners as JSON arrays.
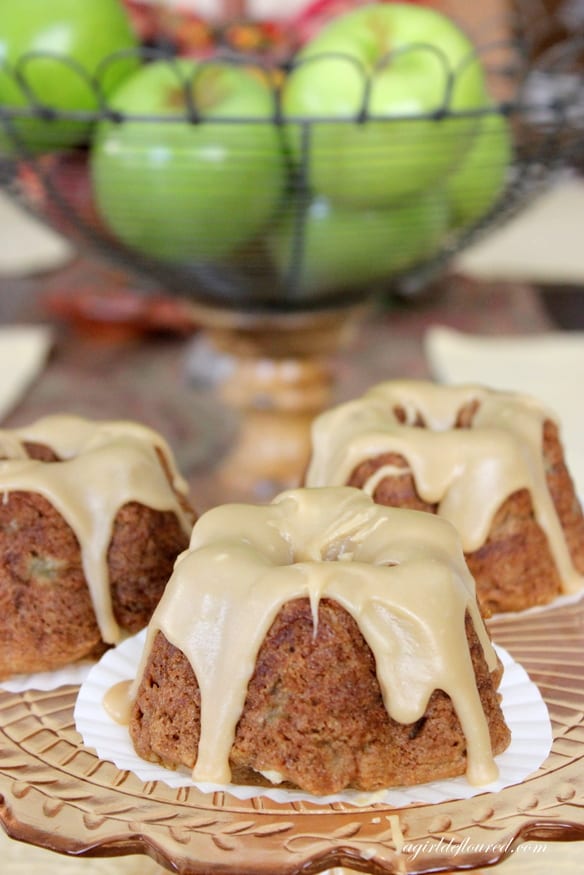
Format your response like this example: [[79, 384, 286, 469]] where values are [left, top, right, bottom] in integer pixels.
[[446, 109, 513, 228]]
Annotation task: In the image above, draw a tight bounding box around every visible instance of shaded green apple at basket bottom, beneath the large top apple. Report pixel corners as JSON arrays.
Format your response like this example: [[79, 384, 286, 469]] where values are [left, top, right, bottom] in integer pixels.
[[267, 190, 449, 298]]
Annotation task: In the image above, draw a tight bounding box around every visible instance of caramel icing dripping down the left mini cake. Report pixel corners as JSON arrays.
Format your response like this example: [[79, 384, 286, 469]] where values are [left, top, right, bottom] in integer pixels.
[[0, 416, 192, 644]]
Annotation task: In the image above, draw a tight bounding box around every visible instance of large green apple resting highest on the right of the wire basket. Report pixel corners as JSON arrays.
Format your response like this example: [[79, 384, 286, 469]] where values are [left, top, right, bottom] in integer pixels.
[[282, 3, 487, 207]]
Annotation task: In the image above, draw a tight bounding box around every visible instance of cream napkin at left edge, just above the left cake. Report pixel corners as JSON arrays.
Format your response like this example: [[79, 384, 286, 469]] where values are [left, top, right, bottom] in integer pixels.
[[0, 325, 52, 421]]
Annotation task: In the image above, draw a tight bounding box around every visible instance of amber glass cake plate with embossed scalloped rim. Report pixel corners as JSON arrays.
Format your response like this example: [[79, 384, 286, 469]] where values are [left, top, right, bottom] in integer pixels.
[[0, 600, 584, 875]]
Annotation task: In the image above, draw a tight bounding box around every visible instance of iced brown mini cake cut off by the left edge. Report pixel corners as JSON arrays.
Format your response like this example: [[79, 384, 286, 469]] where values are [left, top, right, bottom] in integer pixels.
[[0, 415, 195, 679]]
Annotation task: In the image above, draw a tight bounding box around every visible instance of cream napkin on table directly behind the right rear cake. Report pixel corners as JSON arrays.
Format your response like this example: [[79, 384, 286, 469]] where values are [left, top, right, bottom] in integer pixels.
[[425, 326, 584, 497]]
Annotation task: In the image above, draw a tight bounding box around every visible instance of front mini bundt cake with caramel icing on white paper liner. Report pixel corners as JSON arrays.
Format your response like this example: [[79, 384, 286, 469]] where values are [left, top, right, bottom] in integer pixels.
[[124, 487, 510, 795]]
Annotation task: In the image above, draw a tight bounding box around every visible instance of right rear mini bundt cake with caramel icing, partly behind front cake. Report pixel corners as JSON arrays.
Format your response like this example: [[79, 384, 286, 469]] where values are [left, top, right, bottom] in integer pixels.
[[305, 380, 584, 613]]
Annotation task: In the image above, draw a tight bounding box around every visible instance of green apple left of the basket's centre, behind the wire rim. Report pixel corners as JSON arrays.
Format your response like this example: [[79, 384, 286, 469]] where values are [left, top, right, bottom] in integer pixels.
[[90, 58, 285, 263]]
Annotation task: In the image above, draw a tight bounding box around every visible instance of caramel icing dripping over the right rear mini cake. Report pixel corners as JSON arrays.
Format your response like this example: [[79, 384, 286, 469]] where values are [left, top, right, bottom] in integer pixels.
[[306, 380, 583, 592]]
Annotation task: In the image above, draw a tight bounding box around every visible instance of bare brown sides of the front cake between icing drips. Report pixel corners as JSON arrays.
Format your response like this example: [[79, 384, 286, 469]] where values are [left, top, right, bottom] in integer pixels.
[[130, 599, 509, 794]]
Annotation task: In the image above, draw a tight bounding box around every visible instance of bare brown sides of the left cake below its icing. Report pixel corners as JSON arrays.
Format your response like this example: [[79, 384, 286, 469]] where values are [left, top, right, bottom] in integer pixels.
[[0, 491, 187, 678]]
